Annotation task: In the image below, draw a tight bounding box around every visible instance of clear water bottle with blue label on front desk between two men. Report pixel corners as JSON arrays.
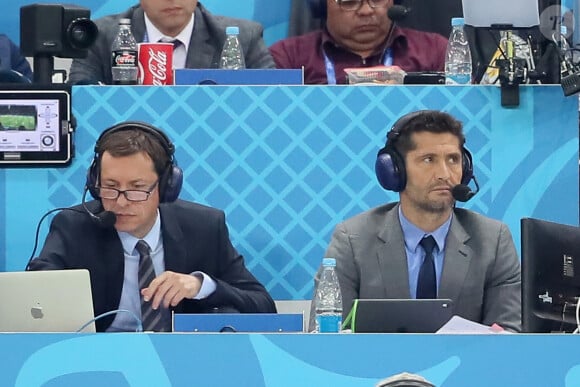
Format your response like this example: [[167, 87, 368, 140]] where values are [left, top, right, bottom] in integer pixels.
[[314, 258, 342, 333]]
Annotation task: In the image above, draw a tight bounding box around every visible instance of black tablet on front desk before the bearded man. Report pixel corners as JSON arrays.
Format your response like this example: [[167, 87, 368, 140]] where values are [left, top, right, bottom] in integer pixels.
[[350, 299, 453, 333]]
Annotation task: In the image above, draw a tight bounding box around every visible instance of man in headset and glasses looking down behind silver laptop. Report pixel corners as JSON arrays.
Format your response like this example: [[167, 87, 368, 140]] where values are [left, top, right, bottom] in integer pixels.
[[29, 122, 276, 331]]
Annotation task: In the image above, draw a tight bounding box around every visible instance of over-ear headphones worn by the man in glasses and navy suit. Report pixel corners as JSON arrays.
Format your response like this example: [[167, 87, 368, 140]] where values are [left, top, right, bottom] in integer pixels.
[[86, 121, 183, 203]]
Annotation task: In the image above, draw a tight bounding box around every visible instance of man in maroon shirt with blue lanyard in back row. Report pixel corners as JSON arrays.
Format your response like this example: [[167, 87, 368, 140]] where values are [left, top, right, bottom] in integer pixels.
[[270, 0, 447, 84]]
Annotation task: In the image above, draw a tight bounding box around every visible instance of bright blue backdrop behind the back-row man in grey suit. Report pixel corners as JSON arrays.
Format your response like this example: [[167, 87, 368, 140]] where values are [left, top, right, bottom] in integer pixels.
[[0, 0, 290, 46]]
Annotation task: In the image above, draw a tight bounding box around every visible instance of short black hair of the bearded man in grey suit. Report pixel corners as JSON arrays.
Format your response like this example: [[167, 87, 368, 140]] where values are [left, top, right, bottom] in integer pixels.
[[394, 110, 465, 158]]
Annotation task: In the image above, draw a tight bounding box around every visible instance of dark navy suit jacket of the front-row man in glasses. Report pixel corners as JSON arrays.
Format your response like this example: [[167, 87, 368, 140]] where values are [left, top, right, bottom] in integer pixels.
[[30, 200, 276, 331]]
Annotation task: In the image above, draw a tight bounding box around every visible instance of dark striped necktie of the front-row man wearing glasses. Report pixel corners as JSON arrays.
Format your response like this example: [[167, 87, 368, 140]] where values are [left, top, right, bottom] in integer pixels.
[[135, 240, 168, 332]]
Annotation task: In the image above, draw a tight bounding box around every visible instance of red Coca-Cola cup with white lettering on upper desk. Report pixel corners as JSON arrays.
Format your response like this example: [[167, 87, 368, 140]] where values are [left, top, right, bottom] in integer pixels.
[[138, 43, 173, 86]]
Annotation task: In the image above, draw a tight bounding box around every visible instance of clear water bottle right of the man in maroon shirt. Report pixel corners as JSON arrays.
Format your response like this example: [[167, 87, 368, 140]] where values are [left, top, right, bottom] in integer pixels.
[[445, 17, 472, 85]]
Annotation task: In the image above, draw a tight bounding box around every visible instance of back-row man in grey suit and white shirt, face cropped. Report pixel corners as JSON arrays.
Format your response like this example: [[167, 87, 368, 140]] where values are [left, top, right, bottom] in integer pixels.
[[69, 0, 274, 84]]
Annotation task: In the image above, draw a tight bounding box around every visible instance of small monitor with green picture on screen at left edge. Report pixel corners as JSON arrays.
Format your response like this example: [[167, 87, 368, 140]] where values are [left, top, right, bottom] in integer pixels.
[[0, 85, 73, 166]]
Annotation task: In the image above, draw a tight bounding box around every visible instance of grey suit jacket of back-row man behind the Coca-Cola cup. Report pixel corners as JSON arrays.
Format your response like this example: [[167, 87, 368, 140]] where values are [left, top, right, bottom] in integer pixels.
[[69, 3, 275, 84]]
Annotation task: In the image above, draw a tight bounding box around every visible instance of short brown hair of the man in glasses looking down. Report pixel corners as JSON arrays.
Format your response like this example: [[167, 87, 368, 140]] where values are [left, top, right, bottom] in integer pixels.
[[97, 128, 171, 176]]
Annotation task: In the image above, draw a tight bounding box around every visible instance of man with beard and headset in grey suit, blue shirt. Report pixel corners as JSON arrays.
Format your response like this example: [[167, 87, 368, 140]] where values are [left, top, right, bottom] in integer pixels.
[[310, 110, 521, 331]]
